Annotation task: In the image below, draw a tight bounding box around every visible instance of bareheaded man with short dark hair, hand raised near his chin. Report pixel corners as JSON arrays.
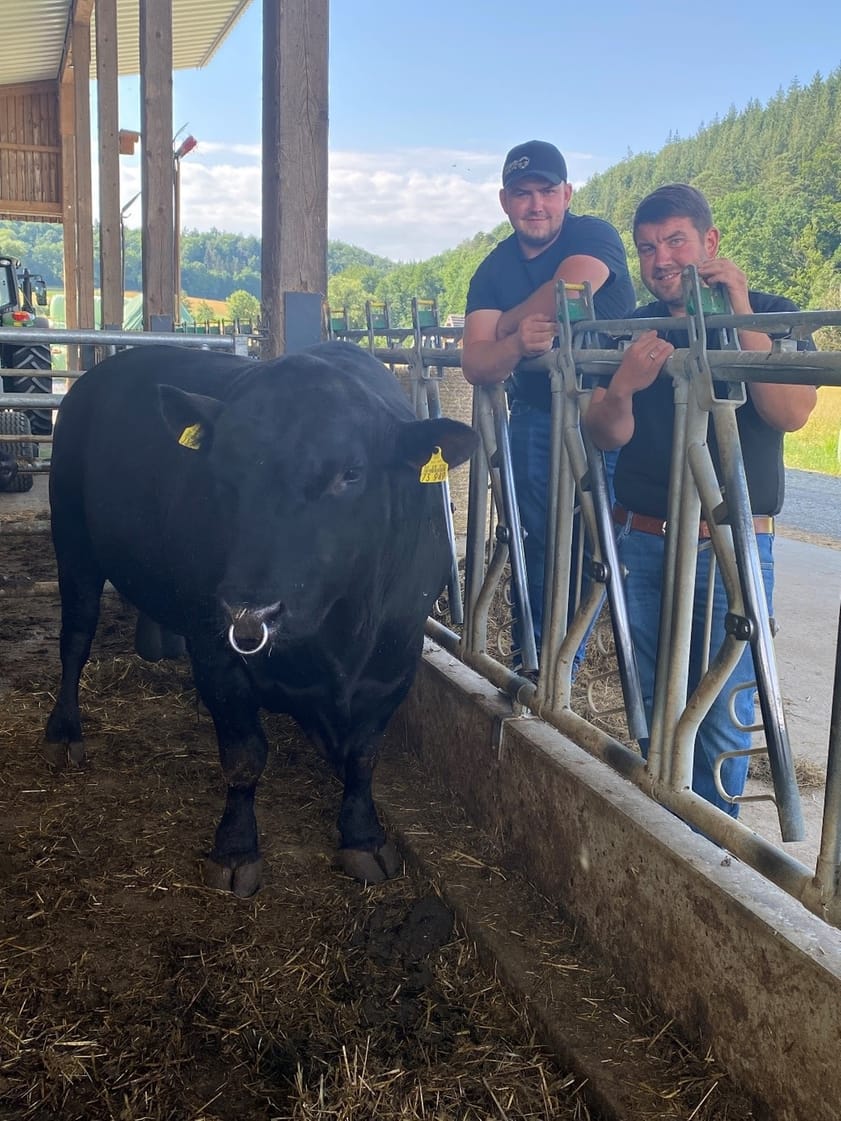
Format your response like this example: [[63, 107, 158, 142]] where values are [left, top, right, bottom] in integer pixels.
[[585, 184, 816, 817]]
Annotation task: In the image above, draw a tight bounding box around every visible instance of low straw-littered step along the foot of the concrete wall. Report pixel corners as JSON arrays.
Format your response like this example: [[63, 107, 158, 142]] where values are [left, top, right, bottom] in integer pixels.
[[376, 753, 735, 1121]]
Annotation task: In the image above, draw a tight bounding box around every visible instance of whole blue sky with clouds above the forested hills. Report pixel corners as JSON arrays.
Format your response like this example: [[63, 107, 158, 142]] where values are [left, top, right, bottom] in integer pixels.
[[112, 0, 841, 260]]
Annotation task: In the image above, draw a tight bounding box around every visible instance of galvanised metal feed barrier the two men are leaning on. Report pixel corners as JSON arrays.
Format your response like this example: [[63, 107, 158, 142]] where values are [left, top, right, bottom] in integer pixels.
[[329, 282, 841, 926]]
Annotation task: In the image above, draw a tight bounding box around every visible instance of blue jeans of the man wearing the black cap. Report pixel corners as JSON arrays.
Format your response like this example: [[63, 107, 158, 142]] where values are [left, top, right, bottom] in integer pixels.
[[508, 402, 619, 676]]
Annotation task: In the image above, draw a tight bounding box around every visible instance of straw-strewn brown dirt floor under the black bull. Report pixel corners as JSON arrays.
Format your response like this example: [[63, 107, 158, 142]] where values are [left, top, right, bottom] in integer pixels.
[[0, 534, 760, 1121]]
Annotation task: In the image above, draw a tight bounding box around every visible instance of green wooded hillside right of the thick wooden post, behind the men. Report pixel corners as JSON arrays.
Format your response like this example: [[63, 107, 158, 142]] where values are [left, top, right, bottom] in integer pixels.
[[329, 70, 841, 322]]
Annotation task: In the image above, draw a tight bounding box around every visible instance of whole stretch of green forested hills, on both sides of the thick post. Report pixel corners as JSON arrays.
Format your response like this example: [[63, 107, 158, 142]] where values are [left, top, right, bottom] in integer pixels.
[[0, 70, 841, 349]]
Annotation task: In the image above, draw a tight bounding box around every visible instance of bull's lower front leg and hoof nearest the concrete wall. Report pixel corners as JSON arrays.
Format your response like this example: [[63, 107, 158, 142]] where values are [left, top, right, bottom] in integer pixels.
[[336, 742, 403, 883]]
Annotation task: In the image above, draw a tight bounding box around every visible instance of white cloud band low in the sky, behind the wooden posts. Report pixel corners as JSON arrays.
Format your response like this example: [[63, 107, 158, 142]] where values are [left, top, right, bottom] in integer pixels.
[[122, 141, 594, 261]]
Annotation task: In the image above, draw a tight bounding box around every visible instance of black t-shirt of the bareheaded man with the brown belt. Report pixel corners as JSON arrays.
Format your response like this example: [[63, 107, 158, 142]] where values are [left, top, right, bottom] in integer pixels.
[[613, 291, 815, 518]]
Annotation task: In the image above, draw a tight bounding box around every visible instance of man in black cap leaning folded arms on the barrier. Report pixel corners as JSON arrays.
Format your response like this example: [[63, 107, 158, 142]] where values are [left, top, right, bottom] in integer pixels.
[[462, 140, 636, 660]]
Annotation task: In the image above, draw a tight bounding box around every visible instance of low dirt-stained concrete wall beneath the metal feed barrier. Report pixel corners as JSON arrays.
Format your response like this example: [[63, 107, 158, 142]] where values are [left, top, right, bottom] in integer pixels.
[[396, 643, 841, 1121]]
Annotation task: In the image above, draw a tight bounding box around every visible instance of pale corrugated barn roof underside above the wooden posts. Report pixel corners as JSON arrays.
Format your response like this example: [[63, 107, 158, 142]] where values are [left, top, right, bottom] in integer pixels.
[[0, 0, 251, 86]]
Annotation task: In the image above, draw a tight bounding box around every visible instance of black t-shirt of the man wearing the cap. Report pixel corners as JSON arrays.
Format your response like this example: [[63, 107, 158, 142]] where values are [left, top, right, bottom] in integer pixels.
[[466, 211, 636, 410]]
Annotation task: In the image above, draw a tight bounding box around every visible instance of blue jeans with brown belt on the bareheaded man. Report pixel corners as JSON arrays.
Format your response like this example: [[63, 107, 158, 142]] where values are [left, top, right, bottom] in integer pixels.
[[618, 528, 774, 817]]
